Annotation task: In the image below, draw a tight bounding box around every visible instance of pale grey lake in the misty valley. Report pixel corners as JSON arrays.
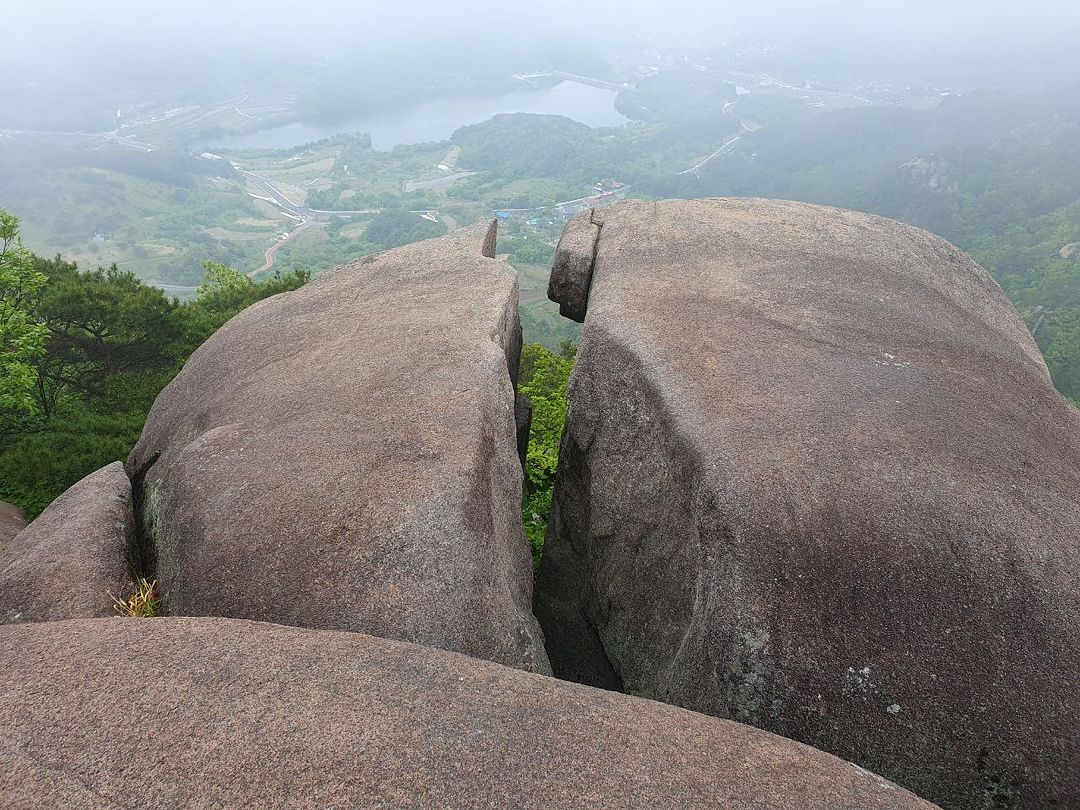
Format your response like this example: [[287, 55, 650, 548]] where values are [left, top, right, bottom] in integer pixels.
[[200, 82, 626, 150]]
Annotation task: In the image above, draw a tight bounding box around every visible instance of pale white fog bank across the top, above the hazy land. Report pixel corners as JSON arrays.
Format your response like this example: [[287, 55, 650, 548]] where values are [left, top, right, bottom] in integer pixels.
[[8, 0, 1080, 126]]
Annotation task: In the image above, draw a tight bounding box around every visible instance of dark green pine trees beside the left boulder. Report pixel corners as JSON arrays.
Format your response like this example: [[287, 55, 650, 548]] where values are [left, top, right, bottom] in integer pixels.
[[0, 244, 309, 518]]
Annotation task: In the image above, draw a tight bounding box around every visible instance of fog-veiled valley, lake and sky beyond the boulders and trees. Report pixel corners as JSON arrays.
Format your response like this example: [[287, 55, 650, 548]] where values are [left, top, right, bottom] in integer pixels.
[[0, 0, 1080, 406]]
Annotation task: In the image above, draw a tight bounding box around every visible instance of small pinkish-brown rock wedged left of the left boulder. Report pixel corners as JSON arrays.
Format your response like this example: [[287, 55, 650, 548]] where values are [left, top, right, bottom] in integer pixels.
[[0, 461, 134, 623]]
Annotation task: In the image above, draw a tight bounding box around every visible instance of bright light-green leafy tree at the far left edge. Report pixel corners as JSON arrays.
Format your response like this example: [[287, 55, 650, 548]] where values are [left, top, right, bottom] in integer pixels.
[[0, 208, 49, 421]]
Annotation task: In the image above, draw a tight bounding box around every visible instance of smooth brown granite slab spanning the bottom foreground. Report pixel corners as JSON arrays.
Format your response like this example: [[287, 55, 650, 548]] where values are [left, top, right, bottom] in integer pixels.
[[0, 618, 932, 810]]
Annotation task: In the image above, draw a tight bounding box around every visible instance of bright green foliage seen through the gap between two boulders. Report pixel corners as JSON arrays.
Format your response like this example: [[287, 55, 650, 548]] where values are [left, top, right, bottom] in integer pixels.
[[518, 342, 578, 566]]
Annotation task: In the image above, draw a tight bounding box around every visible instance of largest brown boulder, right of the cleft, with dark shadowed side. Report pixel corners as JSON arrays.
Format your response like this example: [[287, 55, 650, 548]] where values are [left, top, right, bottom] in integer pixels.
[[537, 200, 1080, 808]]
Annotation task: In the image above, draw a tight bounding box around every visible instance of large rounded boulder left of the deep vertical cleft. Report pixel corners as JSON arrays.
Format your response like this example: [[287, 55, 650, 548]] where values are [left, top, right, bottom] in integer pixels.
[[129, 227, 548, 672]]
